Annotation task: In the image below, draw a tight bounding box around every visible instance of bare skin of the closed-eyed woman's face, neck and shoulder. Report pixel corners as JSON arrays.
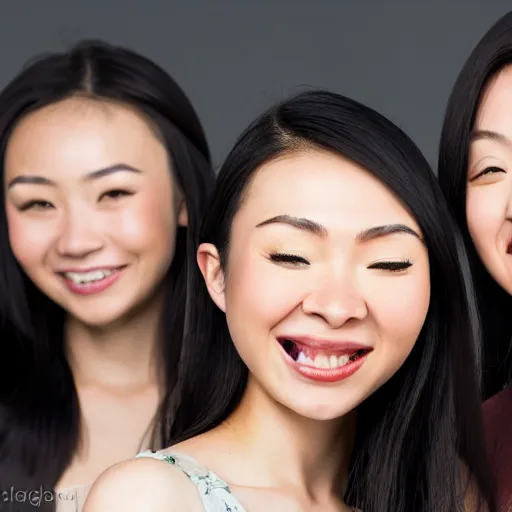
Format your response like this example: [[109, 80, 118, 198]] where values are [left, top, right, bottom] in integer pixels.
[[85, 150, 430, 512]]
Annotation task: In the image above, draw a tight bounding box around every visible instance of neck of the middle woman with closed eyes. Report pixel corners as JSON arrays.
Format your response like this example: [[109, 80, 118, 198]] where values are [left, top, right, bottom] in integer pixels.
[[221, 377, 355, 500]]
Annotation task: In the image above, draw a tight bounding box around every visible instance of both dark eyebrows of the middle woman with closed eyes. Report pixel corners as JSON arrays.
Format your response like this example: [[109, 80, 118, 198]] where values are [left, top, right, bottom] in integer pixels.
[[256, 215, 423, 243]]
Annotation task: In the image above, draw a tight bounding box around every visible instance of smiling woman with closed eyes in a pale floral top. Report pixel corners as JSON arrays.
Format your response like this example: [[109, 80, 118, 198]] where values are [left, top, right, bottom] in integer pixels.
[[85, 91, 493, 512]]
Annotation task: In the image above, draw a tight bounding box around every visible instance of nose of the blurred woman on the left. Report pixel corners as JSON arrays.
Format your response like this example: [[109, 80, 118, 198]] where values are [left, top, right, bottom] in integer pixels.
[[56, 211, 103, 258]]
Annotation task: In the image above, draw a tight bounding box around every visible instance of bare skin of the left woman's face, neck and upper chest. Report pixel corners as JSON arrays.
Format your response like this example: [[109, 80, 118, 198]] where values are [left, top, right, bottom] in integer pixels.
[[3, 96, 187, 489]]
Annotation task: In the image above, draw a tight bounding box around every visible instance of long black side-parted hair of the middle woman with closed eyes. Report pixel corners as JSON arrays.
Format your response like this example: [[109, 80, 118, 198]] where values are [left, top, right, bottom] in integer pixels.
[[172, 91, 493, 512]]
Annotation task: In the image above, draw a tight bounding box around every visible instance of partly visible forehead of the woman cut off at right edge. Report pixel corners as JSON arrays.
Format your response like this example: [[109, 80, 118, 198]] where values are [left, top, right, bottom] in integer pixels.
[[475, 65, 512, 136]]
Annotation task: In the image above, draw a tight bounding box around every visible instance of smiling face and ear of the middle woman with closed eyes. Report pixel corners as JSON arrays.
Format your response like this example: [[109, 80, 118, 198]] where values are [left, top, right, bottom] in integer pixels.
[[198, 150, 430, 420]]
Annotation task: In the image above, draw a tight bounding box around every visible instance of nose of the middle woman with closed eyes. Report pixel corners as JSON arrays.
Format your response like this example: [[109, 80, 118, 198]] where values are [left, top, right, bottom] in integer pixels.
[[302, 273, 368, 329]]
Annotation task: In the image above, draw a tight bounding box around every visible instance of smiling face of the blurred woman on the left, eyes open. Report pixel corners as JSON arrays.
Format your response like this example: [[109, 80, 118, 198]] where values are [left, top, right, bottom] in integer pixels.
[[3, 97, 186, 326]]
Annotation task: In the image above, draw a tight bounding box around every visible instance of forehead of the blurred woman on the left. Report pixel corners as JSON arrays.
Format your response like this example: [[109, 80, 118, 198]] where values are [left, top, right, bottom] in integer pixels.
[[5, 97, 166, 182]]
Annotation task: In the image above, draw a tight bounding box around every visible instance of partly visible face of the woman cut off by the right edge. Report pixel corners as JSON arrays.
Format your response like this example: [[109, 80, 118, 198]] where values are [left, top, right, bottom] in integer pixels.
[[466, 66, 512, 294]]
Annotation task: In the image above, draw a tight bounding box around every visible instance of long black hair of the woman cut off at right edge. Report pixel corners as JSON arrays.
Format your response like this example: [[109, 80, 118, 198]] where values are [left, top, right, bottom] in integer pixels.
[[438, 12, 512, 397]]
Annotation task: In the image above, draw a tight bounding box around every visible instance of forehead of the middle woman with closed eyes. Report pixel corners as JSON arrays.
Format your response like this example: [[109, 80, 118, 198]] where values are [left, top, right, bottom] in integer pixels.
[[239, 150, 417, 230]]
